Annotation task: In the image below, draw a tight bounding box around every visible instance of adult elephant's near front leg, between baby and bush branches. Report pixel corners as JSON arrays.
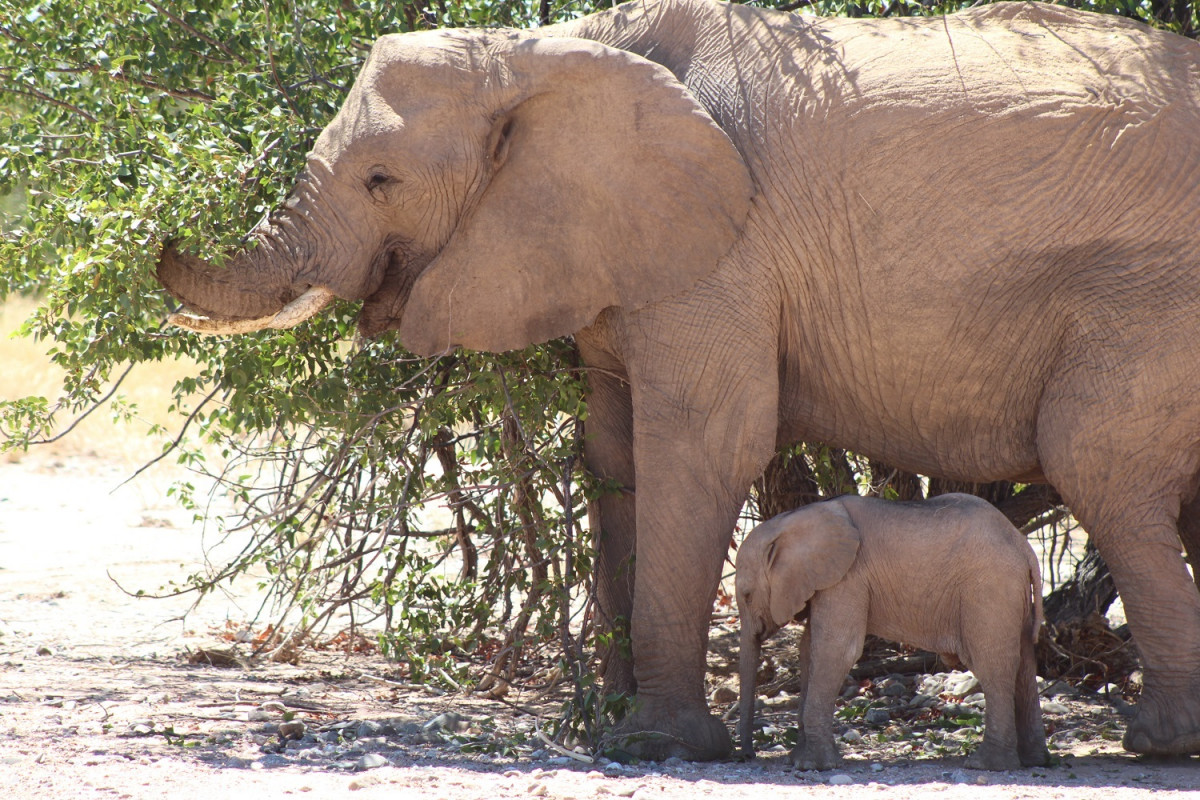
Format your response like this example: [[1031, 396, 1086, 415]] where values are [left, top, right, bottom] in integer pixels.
[[609, 376, 778, 760]]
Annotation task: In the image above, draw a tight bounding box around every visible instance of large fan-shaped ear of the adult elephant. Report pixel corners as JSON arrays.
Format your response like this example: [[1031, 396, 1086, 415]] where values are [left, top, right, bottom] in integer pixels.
[[400, 37, 752, 355]]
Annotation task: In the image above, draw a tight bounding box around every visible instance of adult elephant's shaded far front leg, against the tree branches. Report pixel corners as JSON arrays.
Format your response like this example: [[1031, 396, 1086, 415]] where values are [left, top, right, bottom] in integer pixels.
[[583, 371, 637, 696]]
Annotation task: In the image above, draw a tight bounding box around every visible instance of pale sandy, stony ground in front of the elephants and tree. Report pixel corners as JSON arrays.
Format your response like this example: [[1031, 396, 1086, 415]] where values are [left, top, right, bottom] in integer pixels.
[[0, 457, 1200, 800]]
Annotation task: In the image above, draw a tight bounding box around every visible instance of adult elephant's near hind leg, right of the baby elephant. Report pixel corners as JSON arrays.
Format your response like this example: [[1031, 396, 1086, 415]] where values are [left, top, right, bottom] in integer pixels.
[[1038, 400, 1200, 756]]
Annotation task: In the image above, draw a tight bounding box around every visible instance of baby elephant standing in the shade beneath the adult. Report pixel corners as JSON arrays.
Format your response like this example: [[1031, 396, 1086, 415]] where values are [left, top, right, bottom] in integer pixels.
[[737, 494, 1049, 770]]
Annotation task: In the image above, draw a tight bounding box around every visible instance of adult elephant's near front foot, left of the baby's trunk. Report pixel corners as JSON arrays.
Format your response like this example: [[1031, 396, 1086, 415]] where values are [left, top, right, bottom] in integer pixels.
[[605, 704, 733, 762]]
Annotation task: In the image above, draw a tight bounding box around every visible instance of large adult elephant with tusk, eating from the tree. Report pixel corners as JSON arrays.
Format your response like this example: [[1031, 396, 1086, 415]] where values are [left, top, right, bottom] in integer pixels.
[[158, 0, 1200, 759]]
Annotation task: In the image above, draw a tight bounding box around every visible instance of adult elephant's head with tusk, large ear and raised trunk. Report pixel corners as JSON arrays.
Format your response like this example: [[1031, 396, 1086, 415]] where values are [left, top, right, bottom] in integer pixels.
[[157, 30, 752, 355]]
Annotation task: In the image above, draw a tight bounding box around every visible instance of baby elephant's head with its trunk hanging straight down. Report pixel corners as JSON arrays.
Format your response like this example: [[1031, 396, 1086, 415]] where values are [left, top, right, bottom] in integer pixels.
[[734, 501, 862, 756]]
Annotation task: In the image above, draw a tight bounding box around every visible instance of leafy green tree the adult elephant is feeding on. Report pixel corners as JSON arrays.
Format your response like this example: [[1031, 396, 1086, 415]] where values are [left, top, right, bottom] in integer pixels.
[[0, 0, 599, 705]]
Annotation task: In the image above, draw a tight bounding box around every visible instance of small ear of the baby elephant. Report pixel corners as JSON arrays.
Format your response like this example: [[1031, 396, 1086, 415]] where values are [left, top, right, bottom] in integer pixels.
[[767, 501, 862, 626]]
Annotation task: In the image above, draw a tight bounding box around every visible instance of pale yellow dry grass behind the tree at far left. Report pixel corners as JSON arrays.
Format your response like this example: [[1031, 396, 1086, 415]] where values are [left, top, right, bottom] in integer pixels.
[[0, 297, 201, 468]]
